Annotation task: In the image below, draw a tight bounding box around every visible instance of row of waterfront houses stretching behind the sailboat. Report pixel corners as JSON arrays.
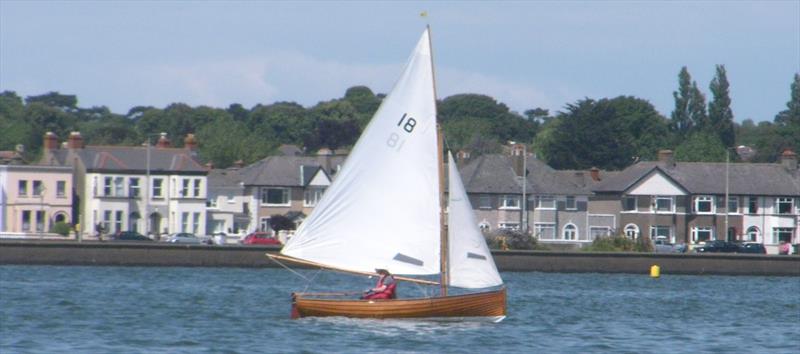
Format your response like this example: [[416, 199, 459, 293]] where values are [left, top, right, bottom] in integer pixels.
[[0, 132, 800, 252]]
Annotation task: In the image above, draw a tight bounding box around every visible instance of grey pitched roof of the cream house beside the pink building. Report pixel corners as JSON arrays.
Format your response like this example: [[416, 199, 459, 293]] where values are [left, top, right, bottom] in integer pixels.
[[46, 146, 206, 174]]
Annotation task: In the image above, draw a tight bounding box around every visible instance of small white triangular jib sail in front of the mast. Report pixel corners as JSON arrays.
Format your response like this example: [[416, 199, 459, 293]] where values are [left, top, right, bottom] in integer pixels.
[[447, 152, 503, 288]]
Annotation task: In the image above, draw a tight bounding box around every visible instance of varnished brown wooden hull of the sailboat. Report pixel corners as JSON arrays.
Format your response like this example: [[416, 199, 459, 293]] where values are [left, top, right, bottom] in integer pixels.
[[292, 288, 506, 320]]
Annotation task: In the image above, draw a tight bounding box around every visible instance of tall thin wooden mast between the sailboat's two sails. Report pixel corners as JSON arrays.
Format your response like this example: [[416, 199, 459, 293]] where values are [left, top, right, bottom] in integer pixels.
[[426, 24, 450, 296]]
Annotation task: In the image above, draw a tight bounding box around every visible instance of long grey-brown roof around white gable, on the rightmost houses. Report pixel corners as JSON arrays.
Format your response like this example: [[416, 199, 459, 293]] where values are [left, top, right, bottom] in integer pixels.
[[593, 162, 800, 196]]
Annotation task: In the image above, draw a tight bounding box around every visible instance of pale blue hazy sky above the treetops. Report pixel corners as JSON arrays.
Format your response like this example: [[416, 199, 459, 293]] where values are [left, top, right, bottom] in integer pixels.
[[0, 0, 800, 122]]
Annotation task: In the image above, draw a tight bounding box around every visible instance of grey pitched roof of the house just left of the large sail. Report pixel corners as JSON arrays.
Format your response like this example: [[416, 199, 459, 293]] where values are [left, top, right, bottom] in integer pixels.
[[241, 155, 345, 187]]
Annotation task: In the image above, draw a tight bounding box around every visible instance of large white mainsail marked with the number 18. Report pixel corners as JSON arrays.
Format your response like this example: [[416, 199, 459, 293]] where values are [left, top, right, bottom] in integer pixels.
[[281, 30, 441, 275]]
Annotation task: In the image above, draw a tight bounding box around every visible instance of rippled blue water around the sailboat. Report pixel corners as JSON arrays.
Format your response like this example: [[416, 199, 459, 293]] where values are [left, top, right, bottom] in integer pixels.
[[0, 266, 800, 353]]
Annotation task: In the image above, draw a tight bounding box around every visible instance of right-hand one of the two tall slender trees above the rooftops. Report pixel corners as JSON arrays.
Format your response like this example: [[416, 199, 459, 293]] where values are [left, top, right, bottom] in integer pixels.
[[708, 65, 736, 147]]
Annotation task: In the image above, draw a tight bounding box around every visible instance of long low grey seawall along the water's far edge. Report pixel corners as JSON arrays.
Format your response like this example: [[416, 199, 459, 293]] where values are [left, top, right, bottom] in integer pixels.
[[0, 240, 800, 276]]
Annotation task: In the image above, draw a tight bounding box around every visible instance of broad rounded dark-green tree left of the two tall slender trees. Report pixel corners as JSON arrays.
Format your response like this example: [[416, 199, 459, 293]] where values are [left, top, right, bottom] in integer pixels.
[[534, 96, 669, 169]]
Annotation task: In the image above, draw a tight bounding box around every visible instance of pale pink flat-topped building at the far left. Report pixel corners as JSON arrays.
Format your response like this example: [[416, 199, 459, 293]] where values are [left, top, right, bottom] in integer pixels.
[[0, 165, 72, 236]]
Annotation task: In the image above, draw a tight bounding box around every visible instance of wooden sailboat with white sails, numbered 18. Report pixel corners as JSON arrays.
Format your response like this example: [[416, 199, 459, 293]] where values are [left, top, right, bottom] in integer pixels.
[[268, 27, 506, 322]]
